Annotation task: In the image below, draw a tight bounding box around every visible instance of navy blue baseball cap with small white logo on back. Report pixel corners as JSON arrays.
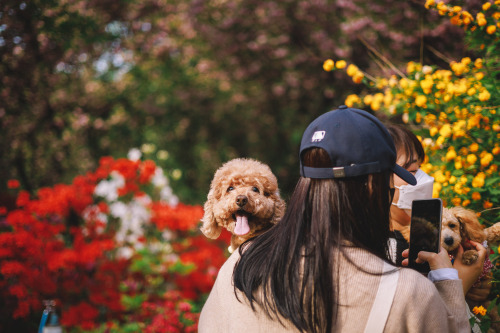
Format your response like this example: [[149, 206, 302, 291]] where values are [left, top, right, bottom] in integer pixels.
[[300, 105, 417, 185]]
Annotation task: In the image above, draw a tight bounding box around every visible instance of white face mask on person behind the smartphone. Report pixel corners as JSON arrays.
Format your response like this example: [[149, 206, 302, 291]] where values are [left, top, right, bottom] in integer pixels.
[[392, 169, 434, 213]]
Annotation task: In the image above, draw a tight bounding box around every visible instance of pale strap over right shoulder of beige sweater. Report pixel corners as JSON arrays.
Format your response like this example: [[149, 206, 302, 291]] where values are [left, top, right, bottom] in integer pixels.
[[365, 261, 399, 333]]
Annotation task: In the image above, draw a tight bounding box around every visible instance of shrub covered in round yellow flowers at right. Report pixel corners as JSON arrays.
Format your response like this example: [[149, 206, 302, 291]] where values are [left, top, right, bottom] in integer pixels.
[[324, 0, 500, 325]]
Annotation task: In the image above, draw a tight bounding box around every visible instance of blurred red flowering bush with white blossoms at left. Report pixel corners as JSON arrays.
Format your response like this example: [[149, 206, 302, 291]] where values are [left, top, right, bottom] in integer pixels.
[[0, 150, 229, 332]]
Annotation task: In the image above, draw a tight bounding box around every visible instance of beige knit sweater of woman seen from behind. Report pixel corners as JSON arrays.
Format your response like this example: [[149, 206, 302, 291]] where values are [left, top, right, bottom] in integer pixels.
[[198, 247, 470, 333]]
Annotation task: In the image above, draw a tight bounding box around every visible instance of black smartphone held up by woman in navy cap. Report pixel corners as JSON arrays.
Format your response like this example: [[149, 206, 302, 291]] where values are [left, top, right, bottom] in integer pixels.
[[408, 199, 443, 273]]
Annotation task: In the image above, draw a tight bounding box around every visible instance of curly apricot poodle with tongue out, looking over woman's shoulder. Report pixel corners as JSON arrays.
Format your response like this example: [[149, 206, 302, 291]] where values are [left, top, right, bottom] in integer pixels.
[[201, 158, 285, 251]]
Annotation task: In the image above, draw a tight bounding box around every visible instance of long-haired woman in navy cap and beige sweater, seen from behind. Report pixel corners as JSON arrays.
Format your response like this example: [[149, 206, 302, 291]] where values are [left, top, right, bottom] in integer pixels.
[[198, 106, 470, 333]]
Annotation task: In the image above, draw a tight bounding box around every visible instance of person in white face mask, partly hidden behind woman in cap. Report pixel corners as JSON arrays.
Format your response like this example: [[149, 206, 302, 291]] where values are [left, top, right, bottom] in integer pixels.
[[386, 124, 491, 312]]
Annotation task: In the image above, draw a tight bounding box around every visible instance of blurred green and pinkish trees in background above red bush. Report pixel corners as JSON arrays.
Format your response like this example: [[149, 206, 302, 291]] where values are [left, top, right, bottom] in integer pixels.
[[0, 0, 481, 205]]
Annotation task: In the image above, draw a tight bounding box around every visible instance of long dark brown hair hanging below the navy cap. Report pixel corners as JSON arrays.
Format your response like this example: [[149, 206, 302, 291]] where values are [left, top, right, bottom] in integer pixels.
[[233, 148, 391, 332]]
